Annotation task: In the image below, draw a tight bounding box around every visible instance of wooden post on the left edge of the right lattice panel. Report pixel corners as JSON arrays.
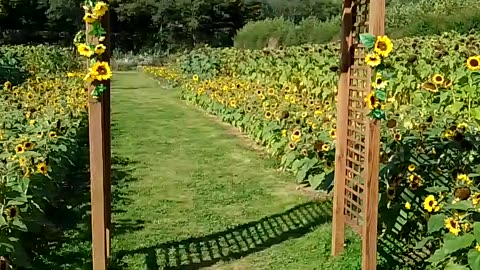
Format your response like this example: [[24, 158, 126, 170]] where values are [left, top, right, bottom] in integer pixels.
[[332, 0, 352, 256]]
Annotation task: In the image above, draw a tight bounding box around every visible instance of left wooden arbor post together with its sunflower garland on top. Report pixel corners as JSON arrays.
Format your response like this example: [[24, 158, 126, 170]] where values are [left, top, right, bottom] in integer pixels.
[[79, 0, 112, 270]]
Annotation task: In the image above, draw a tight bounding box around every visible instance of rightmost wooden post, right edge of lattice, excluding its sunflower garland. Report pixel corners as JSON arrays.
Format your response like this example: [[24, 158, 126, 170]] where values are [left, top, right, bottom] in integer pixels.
[[362, 0, 385, 270]]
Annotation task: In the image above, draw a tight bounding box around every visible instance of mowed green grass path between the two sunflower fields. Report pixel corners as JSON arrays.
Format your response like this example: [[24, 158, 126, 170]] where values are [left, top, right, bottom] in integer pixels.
[[112, 72, 359, 270]]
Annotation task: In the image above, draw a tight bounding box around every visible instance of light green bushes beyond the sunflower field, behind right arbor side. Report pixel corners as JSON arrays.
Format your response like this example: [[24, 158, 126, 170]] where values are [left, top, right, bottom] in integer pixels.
[[234, 0, 480, 49]]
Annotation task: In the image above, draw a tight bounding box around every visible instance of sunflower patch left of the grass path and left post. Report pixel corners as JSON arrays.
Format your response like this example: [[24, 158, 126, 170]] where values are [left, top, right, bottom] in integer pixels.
[[0, 46, 88, 267]]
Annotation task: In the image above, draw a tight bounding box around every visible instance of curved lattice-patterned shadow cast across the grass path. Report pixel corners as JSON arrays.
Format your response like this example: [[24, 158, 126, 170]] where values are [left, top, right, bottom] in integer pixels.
[[110, 201, 332, 270]]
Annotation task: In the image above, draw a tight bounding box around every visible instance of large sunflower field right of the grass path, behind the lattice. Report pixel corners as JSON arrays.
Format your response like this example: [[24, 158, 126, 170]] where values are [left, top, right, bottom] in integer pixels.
[[144, 32, 480, 270]]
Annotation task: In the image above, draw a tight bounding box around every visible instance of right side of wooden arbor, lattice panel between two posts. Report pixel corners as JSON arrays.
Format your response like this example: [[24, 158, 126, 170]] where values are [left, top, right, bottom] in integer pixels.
[[332, 0, 385, 270]]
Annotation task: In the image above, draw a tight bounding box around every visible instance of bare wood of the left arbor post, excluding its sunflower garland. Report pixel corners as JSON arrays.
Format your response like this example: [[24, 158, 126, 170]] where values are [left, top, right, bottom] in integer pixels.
[[86, 9, 111, 270]]
